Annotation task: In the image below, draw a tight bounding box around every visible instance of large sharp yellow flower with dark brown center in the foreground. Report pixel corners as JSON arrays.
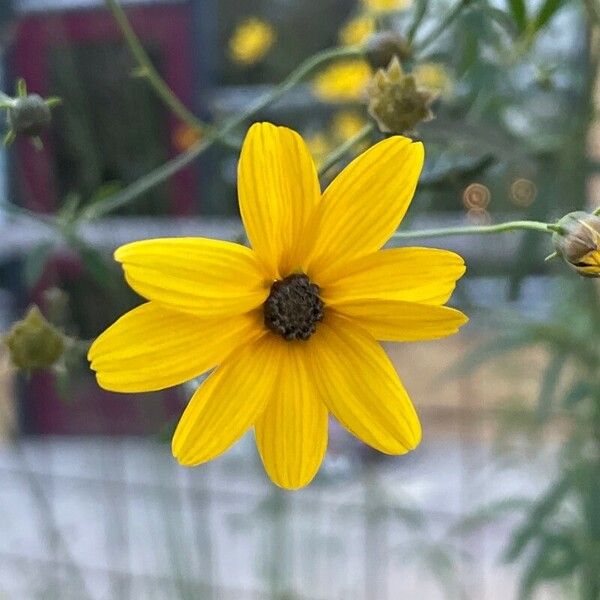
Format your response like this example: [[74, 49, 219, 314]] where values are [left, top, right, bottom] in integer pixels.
[[89, 123, 467, 489]]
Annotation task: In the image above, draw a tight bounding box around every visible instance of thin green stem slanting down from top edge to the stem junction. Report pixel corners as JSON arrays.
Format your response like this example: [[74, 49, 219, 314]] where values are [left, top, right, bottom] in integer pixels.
[[105, 0, 206, 130]]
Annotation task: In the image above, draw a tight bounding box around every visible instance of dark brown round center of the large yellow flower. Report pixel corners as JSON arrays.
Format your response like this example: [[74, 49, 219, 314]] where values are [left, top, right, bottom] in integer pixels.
[[264, 273, 324, 340]]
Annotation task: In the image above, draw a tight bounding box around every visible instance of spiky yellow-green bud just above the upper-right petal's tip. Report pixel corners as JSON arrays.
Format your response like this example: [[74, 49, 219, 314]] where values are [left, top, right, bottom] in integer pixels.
[[368, 57, 435, 133]]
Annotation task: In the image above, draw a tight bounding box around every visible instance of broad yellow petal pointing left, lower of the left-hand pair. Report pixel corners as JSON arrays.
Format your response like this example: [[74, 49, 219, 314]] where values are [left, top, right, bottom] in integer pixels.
[[88, 302, 261, 392]]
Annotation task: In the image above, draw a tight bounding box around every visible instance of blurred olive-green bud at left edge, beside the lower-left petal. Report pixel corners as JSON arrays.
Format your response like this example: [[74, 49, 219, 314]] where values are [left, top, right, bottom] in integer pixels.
[[4, 306, 66, 371]]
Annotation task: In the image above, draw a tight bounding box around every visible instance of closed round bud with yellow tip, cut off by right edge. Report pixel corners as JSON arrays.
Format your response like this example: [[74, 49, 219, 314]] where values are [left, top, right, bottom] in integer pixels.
[[552, 211, 600, 277]]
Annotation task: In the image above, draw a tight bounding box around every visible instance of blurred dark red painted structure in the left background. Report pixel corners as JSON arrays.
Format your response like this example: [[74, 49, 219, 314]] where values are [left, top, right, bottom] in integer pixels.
[[12, 3, 198, 434]]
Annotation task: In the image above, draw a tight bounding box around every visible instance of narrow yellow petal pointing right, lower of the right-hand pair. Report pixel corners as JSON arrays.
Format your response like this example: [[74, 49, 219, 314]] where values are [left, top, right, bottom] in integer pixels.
[[330, 299, 469, 342]]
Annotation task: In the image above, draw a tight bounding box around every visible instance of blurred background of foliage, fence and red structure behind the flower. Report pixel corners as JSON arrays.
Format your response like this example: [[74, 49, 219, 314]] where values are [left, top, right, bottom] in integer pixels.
[[0, 0, 600, 600]]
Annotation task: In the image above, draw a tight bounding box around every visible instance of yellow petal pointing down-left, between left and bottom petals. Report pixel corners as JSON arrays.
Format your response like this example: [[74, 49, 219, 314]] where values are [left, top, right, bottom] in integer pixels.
[[172, 335, 280, 466]]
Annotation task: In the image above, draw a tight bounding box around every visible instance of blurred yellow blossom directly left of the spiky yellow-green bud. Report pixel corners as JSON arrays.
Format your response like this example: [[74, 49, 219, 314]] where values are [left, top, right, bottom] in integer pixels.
[[313, 59, 371, 102]]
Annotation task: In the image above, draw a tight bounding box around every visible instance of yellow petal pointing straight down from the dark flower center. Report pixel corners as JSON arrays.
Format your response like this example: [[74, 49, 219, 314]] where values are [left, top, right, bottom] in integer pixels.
[[255, 340, 327, 489]]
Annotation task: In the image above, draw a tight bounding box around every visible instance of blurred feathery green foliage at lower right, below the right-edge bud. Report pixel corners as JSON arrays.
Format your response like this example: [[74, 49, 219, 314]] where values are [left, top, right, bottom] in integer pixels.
[[456, 278, 600, 599]]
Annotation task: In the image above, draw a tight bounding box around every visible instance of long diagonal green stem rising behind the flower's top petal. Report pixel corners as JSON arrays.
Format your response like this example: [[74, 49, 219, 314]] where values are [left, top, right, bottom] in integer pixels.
[[82, 46, 362, 219]]
